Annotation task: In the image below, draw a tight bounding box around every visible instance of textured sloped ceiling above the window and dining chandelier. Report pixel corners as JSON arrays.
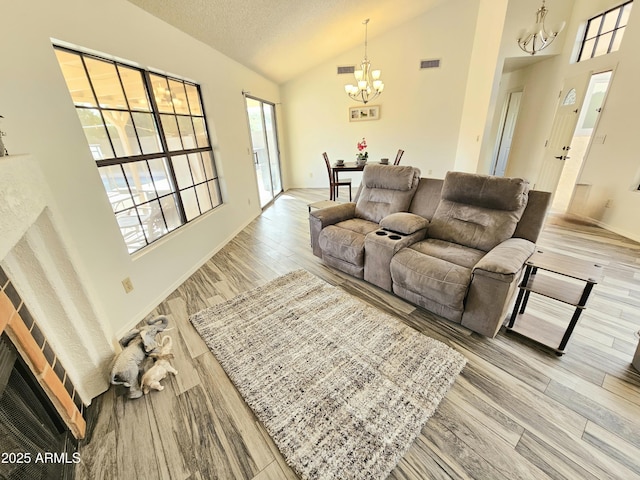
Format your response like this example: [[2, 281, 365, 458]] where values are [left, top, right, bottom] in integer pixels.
[[128, 0, 447, 83]]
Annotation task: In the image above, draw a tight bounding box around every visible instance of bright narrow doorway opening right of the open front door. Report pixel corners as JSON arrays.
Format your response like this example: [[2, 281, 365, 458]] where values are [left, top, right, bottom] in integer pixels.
[[551, 70, 612, 213]]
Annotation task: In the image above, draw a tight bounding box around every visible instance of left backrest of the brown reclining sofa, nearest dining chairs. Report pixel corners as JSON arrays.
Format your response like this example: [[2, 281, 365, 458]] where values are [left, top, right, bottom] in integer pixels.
[[355, 165, 420, 223]]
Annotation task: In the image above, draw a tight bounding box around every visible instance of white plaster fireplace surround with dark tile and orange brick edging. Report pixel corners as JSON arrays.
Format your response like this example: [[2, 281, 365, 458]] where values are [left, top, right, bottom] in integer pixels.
[[0, 155, 114, 450]]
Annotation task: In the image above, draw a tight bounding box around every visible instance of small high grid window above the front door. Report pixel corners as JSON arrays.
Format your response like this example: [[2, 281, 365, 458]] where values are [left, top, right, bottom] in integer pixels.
[[578, 0, 633, 62]]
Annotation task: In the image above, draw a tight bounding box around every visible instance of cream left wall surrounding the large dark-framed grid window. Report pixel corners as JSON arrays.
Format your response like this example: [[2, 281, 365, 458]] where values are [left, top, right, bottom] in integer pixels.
[[0, 0, 280, 352]]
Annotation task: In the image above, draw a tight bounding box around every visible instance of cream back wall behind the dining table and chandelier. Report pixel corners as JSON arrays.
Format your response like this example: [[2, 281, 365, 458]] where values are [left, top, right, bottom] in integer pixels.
[[282, 0, 479, 187]]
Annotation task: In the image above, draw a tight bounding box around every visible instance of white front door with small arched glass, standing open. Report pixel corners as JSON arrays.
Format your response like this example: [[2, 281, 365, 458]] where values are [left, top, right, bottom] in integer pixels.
[[535, 73, 591, 192]]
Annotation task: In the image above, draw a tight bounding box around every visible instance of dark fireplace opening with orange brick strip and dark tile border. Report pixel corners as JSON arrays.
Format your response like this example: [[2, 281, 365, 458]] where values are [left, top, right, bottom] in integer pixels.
[[0, 267, 86, 480]]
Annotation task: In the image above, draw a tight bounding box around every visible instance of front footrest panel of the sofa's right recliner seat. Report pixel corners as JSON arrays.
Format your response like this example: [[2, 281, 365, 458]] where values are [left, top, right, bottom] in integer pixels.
[[391, 246, 471, 312]]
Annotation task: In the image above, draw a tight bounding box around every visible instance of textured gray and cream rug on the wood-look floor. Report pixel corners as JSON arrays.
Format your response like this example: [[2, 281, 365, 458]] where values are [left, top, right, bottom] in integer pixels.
[[191, 270, 466, 479]]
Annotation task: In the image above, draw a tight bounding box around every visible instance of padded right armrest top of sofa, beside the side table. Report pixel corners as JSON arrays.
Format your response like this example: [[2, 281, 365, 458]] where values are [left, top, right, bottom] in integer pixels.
[[473, 238, 536, 282]]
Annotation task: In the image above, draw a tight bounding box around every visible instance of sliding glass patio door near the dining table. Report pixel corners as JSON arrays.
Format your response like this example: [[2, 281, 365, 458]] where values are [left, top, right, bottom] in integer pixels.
[[246, 97, 282, 207]]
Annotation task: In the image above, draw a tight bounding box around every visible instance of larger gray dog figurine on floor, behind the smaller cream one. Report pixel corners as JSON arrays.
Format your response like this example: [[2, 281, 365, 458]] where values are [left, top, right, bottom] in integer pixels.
[[109, 315, 169, 398]]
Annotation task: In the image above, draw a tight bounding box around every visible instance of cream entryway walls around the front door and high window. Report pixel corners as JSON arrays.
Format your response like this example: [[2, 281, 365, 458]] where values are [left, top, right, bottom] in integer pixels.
[[480, 0, 640, 240]]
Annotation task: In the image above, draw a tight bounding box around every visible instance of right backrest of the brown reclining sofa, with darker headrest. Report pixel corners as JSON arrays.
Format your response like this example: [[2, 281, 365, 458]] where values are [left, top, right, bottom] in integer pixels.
[[428, 172, 529, 252]]
